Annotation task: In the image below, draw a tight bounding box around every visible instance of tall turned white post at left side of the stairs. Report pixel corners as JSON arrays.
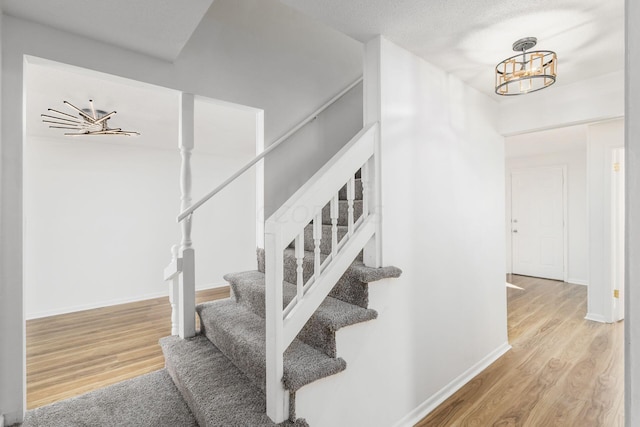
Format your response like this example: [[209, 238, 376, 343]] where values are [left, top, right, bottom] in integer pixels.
[[179, 93, 196, 338]]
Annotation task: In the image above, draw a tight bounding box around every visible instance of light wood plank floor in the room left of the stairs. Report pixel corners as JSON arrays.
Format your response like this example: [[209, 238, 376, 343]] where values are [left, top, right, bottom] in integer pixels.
[[26, 287, 229, 409]]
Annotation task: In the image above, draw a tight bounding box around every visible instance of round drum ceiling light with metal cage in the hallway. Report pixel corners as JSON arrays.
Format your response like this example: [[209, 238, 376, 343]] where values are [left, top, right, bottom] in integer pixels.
[[496, 37, 558, 96]]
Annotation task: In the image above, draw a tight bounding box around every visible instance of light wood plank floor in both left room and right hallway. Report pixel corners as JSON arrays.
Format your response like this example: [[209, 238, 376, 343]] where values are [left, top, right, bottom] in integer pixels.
[[27, 276, 624, 427]]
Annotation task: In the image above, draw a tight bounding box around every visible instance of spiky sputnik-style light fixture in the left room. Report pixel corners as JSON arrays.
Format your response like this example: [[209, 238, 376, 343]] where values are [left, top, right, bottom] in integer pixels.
[[40, 99, 140, 136]]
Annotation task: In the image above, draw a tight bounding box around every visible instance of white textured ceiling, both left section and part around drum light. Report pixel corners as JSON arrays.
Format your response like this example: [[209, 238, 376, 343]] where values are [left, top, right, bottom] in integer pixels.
[[6, 0, 624, 108]]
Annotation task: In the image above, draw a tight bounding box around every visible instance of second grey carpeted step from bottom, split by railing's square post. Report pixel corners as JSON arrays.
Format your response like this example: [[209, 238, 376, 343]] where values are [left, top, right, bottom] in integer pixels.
[[196, 299, 346, 391]]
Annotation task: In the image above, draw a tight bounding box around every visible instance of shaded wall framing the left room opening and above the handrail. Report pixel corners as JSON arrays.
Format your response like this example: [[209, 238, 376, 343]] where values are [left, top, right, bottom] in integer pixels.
[[0, 0, 362, 423]]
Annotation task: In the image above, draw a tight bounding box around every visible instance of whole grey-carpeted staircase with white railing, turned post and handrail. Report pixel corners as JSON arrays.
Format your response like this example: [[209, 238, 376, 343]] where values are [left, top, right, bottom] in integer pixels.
[[20, 79, 401, 427]]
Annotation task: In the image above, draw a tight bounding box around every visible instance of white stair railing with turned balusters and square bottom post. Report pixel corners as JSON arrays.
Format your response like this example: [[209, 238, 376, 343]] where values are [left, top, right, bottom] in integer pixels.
[[265, 123, 380, 423]]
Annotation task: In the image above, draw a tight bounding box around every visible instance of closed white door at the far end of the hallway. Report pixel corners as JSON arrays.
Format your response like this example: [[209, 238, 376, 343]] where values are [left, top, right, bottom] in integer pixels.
[[511, 167, 565, 280]]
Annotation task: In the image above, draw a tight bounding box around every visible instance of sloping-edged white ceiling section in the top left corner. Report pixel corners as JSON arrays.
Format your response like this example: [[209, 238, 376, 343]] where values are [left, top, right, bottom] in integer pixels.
[[0, 0, 213, 61]]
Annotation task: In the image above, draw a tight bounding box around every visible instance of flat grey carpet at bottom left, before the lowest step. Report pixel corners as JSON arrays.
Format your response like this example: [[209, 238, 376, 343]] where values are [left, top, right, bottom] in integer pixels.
[[22, 369, 198, 427]]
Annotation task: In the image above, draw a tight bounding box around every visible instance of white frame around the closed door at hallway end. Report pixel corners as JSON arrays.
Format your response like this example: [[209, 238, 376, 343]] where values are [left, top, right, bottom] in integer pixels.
[[505, 164, 569, 282]]
